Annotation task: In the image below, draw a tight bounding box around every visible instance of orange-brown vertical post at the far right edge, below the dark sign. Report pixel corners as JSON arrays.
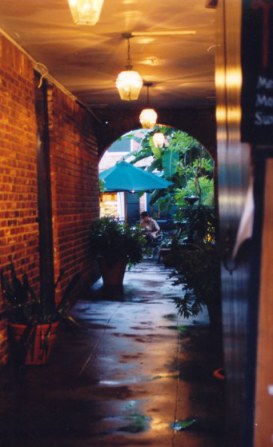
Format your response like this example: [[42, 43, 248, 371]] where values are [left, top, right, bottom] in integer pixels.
[[254, 158, 273, 447]]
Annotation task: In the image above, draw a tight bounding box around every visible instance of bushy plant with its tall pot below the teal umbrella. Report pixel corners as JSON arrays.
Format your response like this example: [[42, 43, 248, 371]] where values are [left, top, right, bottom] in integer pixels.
[[89, 217, 145, 286]]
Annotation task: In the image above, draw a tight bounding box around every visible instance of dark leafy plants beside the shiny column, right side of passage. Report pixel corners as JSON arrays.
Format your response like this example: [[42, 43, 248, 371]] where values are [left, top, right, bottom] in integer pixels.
[[169, 205, 221, 328]]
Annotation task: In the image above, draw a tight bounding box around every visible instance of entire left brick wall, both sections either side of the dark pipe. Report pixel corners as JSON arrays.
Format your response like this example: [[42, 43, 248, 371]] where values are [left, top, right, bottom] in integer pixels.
[[0, 36, 99, 364]]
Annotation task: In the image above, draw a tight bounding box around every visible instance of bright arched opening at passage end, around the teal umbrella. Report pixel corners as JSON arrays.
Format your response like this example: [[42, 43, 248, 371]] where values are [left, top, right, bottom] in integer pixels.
[[99, 125, 214, 236]]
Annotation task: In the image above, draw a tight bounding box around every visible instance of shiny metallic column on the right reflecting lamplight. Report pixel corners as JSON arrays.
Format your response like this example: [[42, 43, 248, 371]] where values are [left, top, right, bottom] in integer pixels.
[[216, 0, 255, 447]]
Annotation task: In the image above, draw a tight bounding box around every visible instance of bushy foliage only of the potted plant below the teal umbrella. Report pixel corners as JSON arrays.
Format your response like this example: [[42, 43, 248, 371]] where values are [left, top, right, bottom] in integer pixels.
[[89, 217, 146, 266]]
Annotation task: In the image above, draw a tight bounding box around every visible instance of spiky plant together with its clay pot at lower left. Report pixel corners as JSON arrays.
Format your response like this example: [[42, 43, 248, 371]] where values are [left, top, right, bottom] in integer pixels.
[[1, 258, 79, 365]]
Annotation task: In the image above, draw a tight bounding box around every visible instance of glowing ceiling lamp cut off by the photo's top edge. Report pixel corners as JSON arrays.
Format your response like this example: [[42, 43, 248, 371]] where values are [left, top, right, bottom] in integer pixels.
[[68, 0, 104, 25]]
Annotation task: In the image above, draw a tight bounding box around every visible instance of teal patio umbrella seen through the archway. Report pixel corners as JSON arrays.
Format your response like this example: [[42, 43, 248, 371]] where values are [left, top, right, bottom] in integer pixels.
[[99, 161, 172, 192]]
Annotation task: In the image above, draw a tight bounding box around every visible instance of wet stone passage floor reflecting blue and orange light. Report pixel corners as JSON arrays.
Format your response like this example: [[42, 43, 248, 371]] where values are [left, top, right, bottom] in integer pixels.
[[0, 260, 224, 447]]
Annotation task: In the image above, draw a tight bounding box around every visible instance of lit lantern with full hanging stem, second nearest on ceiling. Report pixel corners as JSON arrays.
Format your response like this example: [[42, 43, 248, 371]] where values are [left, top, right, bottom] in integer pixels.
[[116, 34, 143, 101]]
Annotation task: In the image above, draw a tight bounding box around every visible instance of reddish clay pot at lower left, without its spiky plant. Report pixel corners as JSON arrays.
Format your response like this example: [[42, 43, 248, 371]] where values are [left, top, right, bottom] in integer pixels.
[[9, 321, 60, 365]]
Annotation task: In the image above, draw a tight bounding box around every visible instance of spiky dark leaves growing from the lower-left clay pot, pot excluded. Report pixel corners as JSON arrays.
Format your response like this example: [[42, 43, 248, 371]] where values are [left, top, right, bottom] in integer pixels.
[[1, 257, 80, 325]]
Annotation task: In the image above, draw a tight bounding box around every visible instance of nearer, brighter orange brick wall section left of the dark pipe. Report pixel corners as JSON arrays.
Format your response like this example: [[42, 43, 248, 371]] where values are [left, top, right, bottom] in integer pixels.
[[0, 37, 39, 368]]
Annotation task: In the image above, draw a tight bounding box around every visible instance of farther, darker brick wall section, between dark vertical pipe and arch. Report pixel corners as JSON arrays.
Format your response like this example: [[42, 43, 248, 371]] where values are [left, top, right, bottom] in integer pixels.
[[48, 87, 99, 298]]
